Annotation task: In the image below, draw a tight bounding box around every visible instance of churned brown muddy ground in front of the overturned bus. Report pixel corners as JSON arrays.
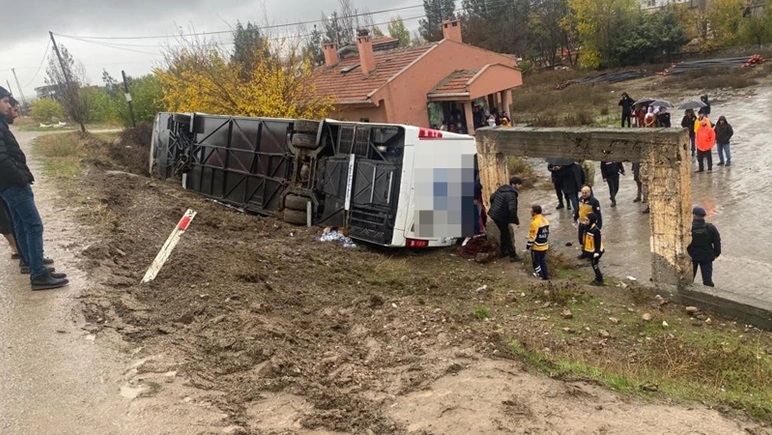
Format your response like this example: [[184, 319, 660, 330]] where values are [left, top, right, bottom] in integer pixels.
[[62, 158, 768, 434]]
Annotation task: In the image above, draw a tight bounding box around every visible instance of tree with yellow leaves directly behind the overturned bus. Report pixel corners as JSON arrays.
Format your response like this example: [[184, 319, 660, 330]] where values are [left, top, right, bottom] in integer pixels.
[[155, 26, 331, 119]]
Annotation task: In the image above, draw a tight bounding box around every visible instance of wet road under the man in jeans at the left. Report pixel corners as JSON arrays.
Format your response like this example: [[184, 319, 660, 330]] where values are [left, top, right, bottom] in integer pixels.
[[0, 133, 223, 435]]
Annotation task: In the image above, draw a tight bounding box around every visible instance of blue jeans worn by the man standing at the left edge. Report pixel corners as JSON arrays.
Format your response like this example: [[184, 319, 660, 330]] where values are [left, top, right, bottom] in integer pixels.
[[0, 184, 48, 278]]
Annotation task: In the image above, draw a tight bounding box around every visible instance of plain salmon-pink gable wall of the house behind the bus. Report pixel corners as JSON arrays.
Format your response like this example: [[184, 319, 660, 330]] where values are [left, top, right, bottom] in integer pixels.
[[376, 40, 522, 126]]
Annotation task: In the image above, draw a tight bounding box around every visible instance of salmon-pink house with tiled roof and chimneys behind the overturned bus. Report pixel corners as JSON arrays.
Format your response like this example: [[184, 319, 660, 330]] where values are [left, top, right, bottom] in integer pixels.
[[312, 20, 523, 134]]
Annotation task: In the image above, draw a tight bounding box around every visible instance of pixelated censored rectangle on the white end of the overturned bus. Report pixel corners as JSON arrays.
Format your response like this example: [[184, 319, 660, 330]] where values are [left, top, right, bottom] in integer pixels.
[[414, 141, 475, 238]]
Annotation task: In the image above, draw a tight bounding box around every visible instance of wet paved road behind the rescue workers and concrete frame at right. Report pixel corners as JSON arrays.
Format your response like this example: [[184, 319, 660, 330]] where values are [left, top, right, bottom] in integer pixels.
[[517, 88, 772, 310]]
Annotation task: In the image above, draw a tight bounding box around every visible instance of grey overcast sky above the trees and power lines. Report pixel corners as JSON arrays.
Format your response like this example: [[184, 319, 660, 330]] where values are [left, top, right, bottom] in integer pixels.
[[0, 0, 423, 98]]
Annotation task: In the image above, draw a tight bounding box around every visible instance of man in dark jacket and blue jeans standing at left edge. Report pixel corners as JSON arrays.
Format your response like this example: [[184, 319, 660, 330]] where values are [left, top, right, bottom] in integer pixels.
[[0, 87, 69, 290]]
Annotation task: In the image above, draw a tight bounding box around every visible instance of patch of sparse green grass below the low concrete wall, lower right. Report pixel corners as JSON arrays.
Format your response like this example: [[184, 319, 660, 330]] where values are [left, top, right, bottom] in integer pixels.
[[508, 287, 772, 421]]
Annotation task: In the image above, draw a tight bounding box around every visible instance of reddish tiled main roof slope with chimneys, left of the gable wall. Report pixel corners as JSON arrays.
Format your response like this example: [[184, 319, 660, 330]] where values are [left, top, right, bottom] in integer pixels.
[[311, 44, 436, 103]]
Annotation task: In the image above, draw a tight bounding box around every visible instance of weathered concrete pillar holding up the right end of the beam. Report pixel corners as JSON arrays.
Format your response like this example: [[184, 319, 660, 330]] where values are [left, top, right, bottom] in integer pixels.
[[641, 133, 693, 289]]
